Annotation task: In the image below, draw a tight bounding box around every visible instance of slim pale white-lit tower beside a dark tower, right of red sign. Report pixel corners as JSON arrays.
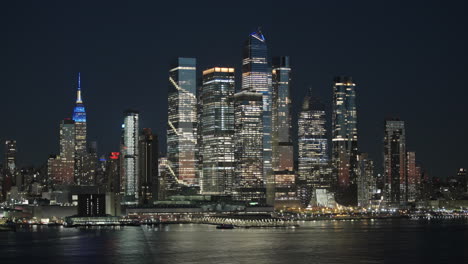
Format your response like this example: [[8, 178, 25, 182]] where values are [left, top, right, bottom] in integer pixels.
[[120, 110, 140, 204]]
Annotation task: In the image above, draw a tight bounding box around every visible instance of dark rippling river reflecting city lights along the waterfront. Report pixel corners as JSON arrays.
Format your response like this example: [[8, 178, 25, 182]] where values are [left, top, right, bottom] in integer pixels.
[[0, 220, 468, 264]]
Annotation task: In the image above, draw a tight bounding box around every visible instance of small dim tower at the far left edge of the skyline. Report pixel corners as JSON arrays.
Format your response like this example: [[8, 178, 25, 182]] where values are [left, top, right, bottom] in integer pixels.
[[2, 140, 18, 198]]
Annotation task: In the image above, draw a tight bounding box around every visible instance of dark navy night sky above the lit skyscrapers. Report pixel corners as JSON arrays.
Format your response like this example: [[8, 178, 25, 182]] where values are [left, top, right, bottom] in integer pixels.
[[0, 0, 468, 177]]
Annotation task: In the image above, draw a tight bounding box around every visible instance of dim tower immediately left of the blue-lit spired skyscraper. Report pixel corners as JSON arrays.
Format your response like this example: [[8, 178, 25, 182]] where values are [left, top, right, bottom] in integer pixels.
[[55, 118, 76, 185]]
